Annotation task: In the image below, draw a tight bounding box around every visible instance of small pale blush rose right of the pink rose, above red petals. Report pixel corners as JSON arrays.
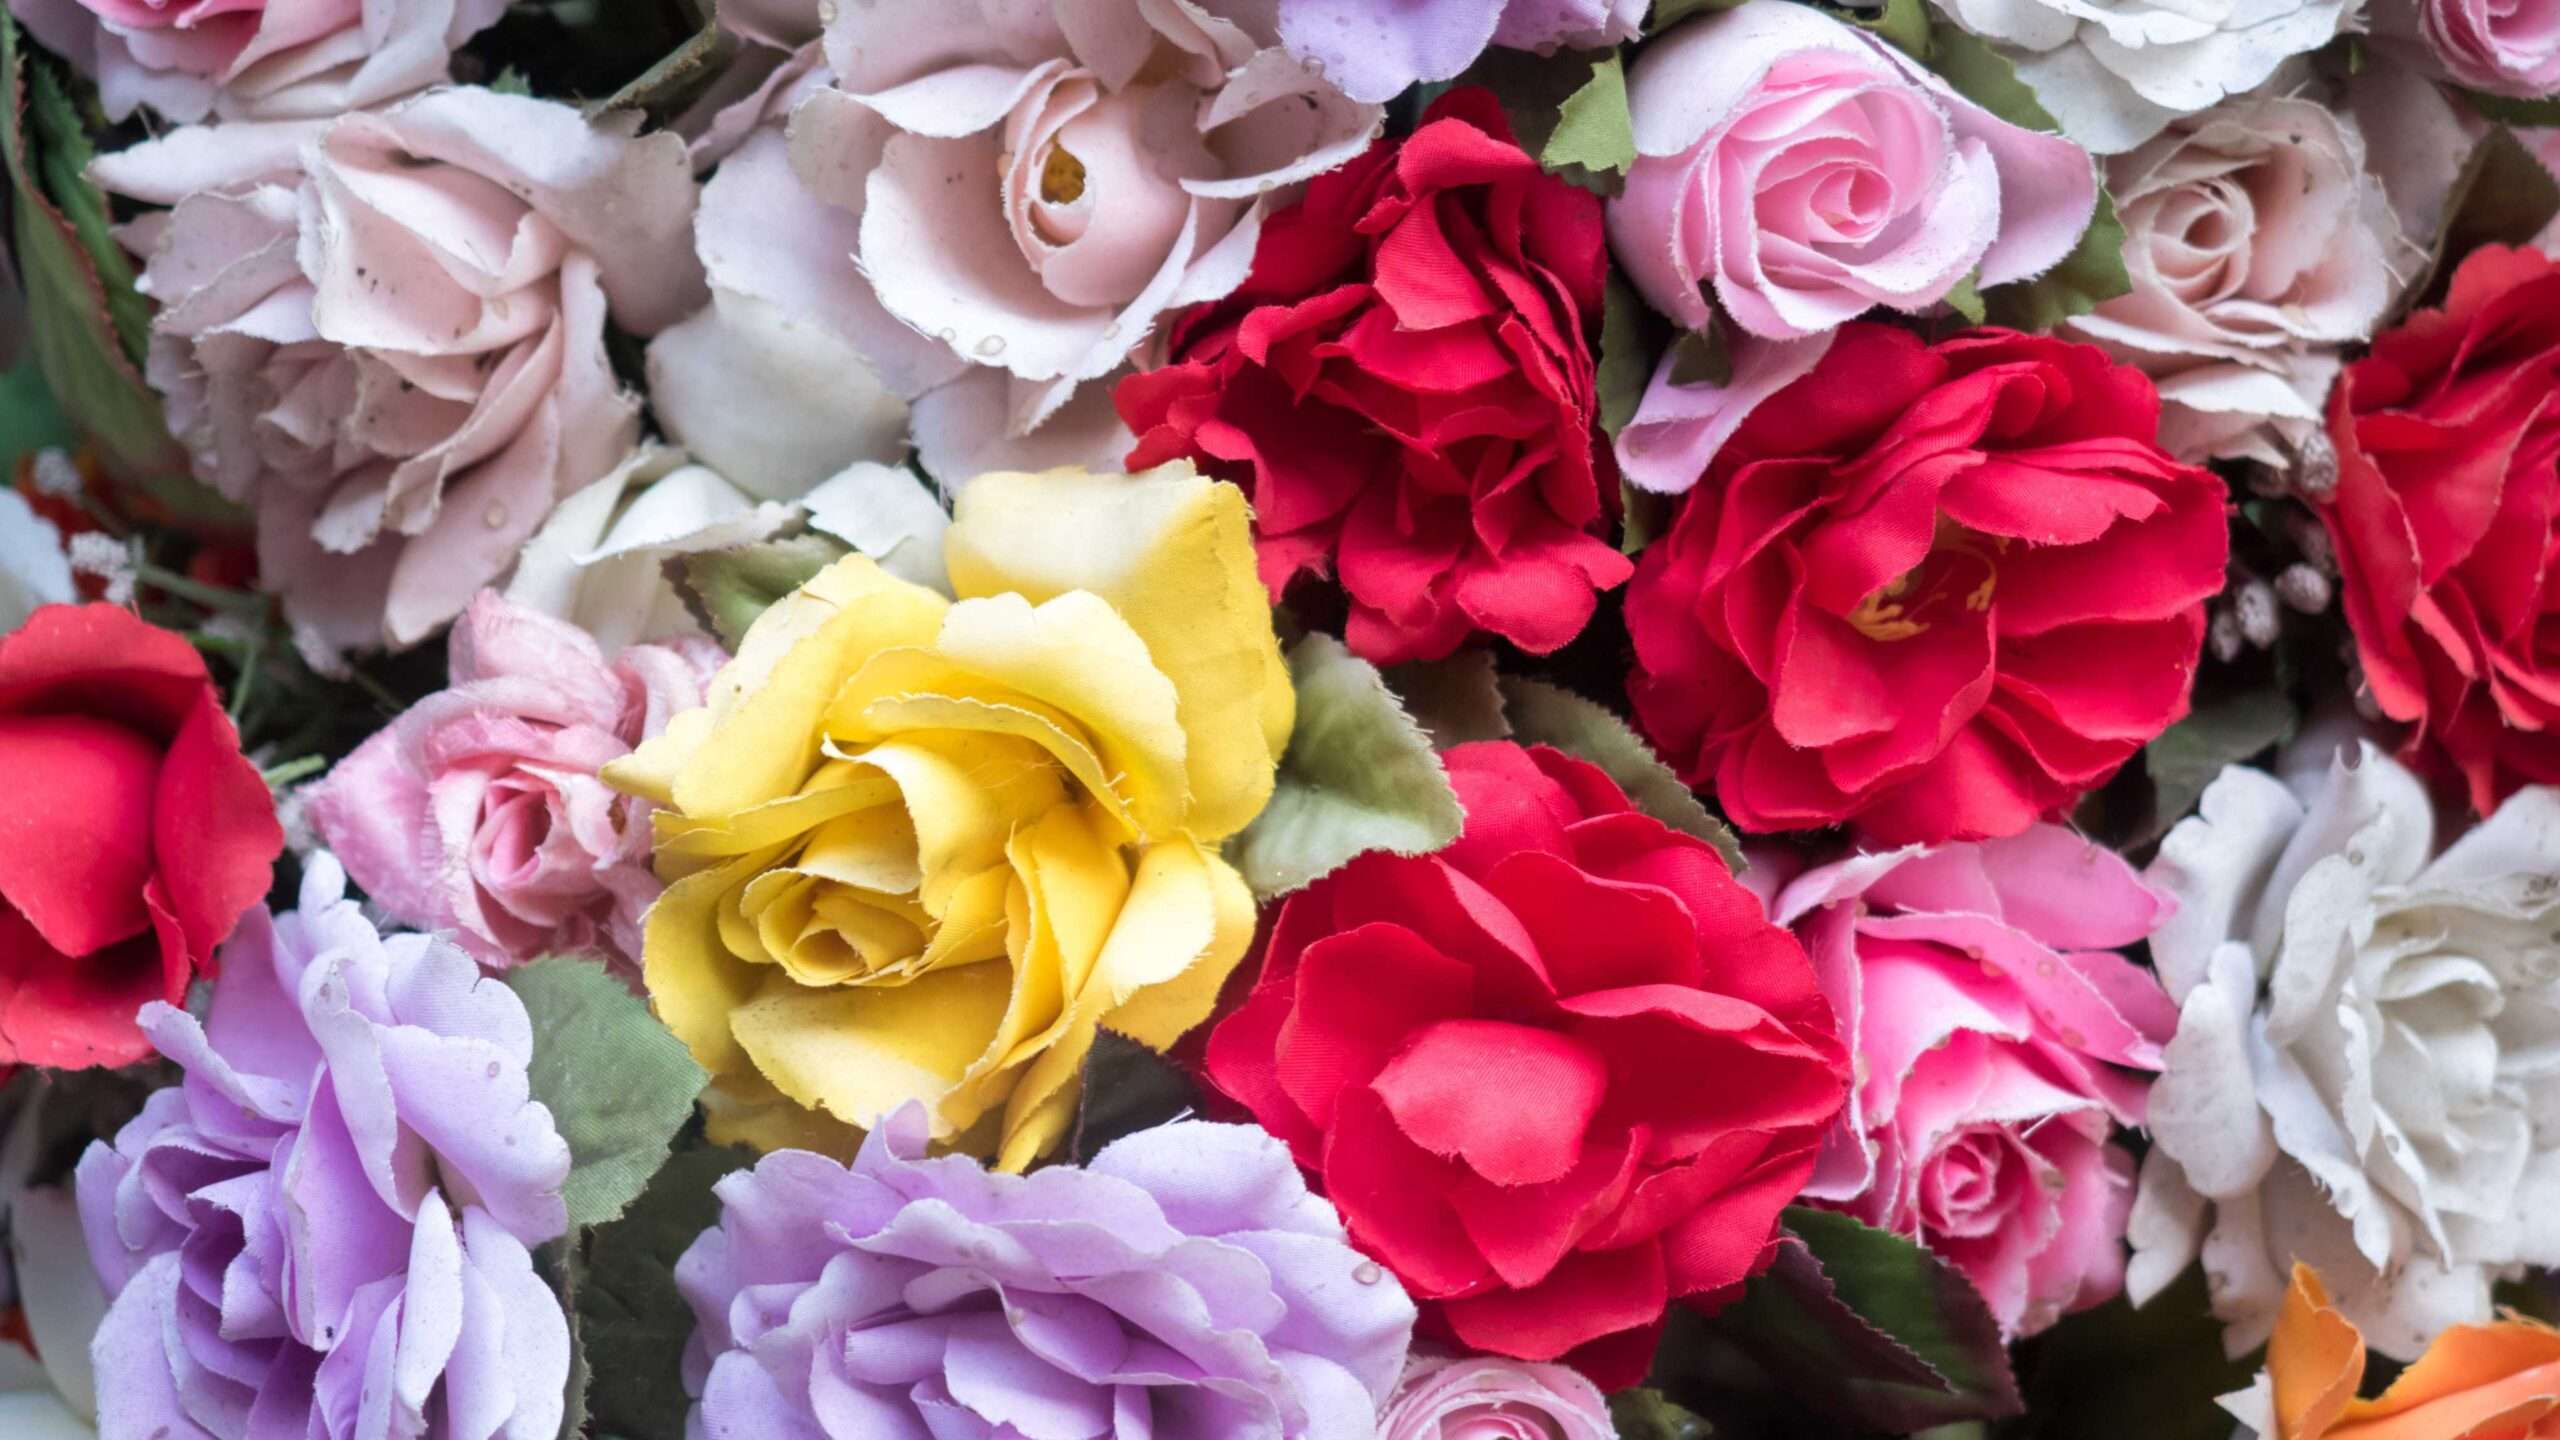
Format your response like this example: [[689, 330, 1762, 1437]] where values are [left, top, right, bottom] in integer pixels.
[[2071, 97, 2422, 466]]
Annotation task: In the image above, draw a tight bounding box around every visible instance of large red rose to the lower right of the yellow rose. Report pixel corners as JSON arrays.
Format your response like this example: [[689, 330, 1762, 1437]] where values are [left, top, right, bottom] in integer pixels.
[[1208, 743, 1846, 1389]]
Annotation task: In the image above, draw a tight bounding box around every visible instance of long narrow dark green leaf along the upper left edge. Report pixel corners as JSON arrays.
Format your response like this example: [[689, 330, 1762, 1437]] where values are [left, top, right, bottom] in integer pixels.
[[0, 15, 202, 507]]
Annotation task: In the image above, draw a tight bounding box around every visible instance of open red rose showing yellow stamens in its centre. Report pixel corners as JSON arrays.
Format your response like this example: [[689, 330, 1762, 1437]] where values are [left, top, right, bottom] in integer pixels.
[[1626, 323, 2230, 843]]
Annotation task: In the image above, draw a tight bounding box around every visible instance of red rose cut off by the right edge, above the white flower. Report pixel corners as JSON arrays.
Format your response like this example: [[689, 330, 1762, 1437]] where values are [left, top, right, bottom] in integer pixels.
[[2322, 246, 2560, 815]]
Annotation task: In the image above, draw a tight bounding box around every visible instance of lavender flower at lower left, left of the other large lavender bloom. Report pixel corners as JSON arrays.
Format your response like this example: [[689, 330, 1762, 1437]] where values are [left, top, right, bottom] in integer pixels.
[[77, 853, 568, 1440]]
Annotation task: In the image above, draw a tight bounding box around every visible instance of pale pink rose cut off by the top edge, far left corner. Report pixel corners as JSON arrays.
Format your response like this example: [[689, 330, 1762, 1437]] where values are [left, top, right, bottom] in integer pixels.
[[10, 0, 507, 123]]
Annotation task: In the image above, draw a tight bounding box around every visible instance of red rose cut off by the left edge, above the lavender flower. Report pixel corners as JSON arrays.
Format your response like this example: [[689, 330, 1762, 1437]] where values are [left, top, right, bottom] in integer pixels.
[[0, 605, 284, 1066]]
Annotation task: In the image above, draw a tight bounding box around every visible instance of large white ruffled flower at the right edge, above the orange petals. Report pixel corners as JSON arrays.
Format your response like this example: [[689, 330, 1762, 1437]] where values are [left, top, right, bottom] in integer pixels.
[[2127, 746, 2560, 1358]]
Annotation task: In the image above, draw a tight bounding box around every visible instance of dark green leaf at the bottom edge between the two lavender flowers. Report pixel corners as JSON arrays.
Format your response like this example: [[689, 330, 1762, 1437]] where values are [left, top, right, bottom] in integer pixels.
[[563, 1132, 755, 1440]]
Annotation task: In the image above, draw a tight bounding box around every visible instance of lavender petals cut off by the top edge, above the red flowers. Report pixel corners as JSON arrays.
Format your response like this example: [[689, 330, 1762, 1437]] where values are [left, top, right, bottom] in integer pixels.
[[1277, 0, 1651, 102]]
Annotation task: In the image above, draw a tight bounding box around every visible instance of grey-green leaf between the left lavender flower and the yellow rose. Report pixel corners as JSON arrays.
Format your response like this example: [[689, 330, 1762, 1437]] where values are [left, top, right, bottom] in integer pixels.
[[507, 956, 712, 1230]]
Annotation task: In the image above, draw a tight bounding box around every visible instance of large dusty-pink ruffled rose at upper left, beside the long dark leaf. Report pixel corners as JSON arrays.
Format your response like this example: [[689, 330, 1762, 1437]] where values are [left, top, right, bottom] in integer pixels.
[[92, 90, 704, 656]]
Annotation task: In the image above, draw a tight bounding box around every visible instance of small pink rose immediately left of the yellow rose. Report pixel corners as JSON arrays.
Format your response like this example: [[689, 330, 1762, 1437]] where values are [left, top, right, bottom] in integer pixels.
[[307, 589, 727, 976]]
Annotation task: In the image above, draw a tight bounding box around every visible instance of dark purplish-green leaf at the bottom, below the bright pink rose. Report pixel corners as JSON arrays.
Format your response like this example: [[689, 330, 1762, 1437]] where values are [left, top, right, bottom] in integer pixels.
[[1715, 1207, 2022, 1435]]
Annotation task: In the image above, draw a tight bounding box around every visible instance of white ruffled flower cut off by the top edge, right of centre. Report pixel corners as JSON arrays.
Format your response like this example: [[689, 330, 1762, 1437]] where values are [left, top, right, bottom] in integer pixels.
[[1946, 0, 2358, 154]]
